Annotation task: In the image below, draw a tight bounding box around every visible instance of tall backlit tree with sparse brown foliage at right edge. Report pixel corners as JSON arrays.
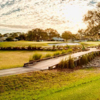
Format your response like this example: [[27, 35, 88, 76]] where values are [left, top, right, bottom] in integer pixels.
[[84, 3, 100, 36]]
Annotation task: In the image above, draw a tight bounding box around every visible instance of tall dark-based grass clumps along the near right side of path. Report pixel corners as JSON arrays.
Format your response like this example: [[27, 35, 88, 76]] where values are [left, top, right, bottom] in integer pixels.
[[56, 52, 100, 69]]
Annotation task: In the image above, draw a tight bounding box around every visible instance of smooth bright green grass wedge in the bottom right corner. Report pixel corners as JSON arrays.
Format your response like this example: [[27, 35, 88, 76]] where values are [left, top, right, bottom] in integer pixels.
[[39, 79, 100, 100]]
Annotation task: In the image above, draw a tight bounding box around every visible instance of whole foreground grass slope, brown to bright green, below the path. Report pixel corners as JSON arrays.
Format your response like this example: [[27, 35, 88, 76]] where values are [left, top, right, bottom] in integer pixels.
[[0, 68, 100, 100]]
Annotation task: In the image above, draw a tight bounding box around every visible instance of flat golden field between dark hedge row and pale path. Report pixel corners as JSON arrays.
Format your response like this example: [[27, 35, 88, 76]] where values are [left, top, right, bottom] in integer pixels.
[[0, 51, 54, 69]]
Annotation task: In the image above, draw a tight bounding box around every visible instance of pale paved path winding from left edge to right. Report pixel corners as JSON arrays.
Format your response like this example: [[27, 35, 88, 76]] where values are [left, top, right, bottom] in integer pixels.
[[0, 48, 100, 77]]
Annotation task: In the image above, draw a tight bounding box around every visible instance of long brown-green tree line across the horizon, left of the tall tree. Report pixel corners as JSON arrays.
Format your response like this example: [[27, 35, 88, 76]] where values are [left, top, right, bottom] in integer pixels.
[[0, 28, 76, 41]]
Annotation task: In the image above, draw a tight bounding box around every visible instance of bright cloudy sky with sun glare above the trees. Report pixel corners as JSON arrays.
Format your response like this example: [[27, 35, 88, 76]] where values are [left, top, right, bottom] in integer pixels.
[[0, 0, 99, 34]]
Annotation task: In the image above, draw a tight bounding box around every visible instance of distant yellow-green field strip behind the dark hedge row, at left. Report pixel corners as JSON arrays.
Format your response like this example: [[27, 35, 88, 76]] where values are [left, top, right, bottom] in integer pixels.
[[0, 41, 61, 47]]
